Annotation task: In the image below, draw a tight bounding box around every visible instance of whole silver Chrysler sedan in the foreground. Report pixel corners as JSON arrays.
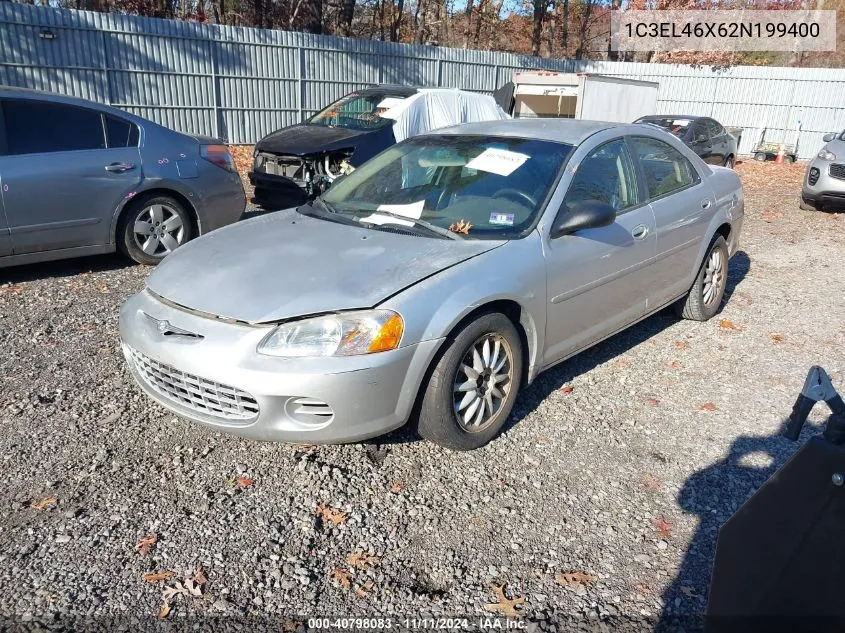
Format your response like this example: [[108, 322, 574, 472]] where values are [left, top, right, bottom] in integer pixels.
[[120, 119, 744, 449]]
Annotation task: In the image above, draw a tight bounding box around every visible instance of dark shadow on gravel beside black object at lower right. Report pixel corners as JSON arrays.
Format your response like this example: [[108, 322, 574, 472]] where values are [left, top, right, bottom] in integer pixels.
[[654, 414, 821, 633]]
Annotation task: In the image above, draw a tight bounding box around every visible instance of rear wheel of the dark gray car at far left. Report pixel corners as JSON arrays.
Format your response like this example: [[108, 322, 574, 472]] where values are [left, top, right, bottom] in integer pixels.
[[117, 196, 194, 266]]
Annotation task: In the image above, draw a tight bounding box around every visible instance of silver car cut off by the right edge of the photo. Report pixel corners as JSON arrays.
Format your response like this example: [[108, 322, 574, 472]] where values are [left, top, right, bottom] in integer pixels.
[[800, 132, 845, 211]]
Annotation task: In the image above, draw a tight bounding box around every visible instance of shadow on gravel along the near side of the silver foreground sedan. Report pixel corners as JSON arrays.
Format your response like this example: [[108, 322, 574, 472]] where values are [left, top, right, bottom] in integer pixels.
[[503, 251, 751, 430]]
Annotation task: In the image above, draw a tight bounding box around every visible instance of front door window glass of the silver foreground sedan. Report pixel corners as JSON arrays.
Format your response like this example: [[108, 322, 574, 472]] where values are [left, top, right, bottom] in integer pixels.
[[563, 139, 640, 212]]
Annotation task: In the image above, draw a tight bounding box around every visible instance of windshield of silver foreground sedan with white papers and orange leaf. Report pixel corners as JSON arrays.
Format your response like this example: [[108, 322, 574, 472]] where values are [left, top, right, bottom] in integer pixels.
[[322, 136, 572, 239]]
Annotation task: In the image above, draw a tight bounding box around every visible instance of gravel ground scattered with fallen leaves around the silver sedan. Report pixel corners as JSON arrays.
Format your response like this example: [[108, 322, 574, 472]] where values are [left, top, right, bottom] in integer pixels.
[[0, 163, 845, 631]]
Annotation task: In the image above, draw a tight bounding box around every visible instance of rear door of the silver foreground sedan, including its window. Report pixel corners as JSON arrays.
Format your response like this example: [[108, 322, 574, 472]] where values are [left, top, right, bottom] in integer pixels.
[[631, 136, 714, 310]]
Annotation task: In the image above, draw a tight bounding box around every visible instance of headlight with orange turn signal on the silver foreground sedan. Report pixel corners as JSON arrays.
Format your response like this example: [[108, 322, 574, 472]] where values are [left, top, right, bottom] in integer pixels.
[[258, 310, 405, 357]]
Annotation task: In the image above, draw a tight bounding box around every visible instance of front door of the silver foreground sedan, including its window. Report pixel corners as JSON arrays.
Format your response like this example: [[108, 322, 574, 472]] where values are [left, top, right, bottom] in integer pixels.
[[543, 138, 655, 366]]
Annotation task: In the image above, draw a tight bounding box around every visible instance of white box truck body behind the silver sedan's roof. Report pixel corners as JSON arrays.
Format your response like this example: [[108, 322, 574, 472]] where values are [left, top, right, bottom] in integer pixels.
[[494, 71, 659, 123]]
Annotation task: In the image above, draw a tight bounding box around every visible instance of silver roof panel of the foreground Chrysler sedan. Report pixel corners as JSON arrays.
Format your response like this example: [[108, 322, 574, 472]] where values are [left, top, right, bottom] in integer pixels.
[[429, 118, 627, 145]]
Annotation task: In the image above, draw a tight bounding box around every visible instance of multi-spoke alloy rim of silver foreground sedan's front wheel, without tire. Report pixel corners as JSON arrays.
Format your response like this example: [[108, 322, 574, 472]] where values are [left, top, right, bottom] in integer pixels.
[[453, 333, 513, 433]]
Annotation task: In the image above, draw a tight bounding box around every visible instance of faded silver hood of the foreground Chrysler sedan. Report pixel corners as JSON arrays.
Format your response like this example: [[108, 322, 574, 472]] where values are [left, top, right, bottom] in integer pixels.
[[147, 210, 504, 323]]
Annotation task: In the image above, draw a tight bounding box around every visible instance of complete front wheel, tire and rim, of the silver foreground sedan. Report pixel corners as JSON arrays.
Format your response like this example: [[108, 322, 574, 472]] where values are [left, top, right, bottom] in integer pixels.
[[417, 312, 523, 451]]
